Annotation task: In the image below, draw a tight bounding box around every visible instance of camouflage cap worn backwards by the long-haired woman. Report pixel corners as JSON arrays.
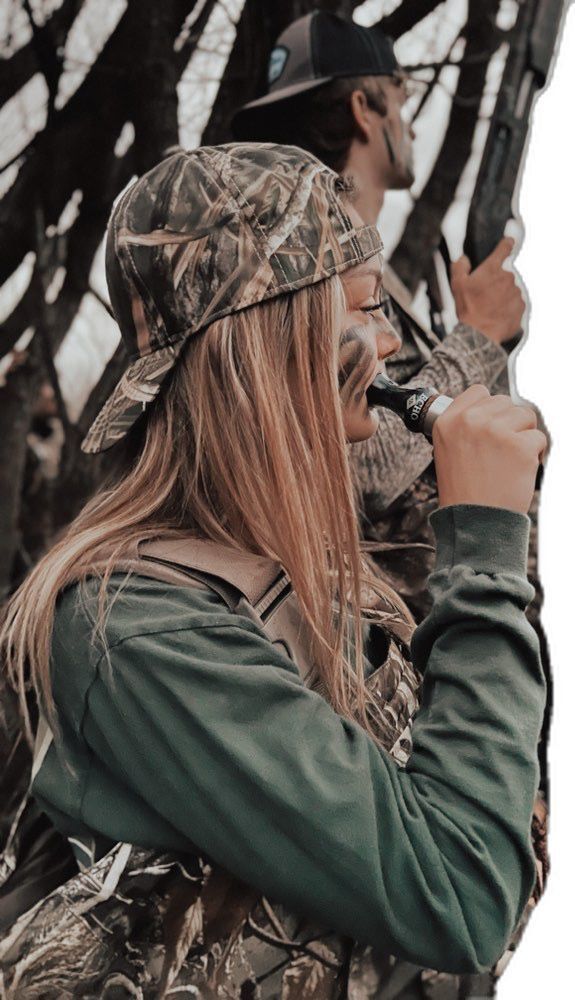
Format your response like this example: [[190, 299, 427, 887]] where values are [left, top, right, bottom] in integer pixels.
[[82, 143, 383, 453]]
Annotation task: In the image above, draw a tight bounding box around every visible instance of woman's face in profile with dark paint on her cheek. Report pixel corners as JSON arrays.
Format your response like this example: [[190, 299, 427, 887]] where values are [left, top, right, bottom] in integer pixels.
[[338, 257, 401, 441]]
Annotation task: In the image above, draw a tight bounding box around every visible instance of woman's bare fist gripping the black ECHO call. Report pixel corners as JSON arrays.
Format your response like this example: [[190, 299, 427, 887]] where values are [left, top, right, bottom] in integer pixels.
[[433, 385, 547, 514]]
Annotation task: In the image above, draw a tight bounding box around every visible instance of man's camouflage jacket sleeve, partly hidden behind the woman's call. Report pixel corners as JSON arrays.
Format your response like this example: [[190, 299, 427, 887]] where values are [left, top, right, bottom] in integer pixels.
[[351, 323, 509, 511]]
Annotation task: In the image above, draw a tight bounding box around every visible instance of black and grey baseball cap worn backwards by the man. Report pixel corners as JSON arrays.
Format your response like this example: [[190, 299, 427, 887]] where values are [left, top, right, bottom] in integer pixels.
[[232, 10, 400, 131]]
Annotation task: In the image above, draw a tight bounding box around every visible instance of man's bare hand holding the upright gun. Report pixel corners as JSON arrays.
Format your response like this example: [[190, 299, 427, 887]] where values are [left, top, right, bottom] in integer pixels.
[[451, 237, 525, 344]]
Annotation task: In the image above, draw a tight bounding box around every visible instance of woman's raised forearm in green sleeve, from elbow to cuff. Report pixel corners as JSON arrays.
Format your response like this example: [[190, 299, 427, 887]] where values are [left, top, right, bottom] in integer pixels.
[[398, 506, 545, 965]]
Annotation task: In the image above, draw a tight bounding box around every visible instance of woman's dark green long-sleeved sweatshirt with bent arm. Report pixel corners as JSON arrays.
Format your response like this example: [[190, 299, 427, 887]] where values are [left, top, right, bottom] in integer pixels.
[[34, 506, 544, 972]]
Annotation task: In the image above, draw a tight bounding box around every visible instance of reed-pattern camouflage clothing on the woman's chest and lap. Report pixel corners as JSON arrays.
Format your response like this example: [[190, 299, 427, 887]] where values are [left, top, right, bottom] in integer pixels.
[[0, 614, 420, 1000]]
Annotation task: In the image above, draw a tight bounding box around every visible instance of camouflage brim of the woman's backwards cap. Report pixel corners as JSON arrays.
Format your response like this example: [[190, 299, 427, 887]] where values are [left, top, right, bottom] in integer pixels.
[[82, 340, 186, 455]]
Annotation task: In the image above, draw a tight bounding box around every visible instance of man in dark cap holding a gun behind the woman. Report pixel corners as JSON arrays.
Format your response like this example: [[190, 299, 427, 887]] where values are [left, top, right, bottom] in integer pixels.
[[232, 11, 524, 619]]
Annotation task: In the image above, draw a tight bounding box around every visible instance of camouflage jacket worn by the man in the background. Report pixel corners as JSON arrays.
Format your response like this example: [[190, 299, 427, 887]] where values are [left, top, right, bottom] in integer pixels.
[[351, 286, 542, 631]]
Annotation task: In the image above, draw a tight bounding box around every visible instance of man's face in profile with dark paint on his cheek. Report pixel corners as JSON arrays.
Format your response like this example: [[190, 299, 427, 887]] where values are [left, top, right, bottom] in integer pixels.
[[366, 76, 415, 191]]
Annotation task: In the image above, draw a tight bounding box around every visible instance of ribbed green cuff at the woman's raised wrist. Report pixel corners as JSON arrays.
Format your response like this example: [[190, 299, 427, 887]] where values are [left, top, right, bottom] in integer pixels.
[[430, 504, 531, 576]]
